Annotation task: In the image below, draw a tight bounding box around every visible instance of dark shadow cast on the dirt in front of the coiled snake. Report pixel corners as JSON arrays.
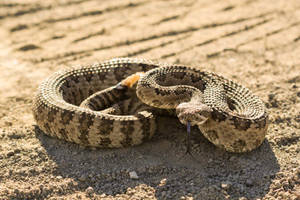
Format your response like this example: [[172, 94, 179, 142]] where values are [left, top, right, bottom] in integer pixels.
[[34, 117, 279, 199]]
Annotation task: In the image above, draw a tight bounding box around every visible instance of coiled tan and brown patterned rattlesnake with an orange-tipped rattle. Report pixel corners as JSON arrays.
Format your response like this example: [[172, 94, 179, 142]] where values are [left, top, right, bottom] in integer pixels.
[[32, 58, 269, 153]]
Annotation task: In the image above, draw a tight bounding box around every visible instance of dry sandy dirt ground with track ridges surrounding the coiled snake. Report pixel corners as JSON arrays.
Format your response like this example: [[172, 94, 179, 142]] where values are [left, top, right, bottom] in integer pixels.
[[0, 0, 300, 200]]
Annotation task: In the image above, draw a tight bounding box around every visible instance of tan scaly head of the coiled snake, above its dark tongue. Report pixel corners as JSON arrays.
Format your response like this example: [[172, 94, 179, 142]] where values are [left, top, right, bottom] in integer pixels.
[[176, 102, 213, 126]]
